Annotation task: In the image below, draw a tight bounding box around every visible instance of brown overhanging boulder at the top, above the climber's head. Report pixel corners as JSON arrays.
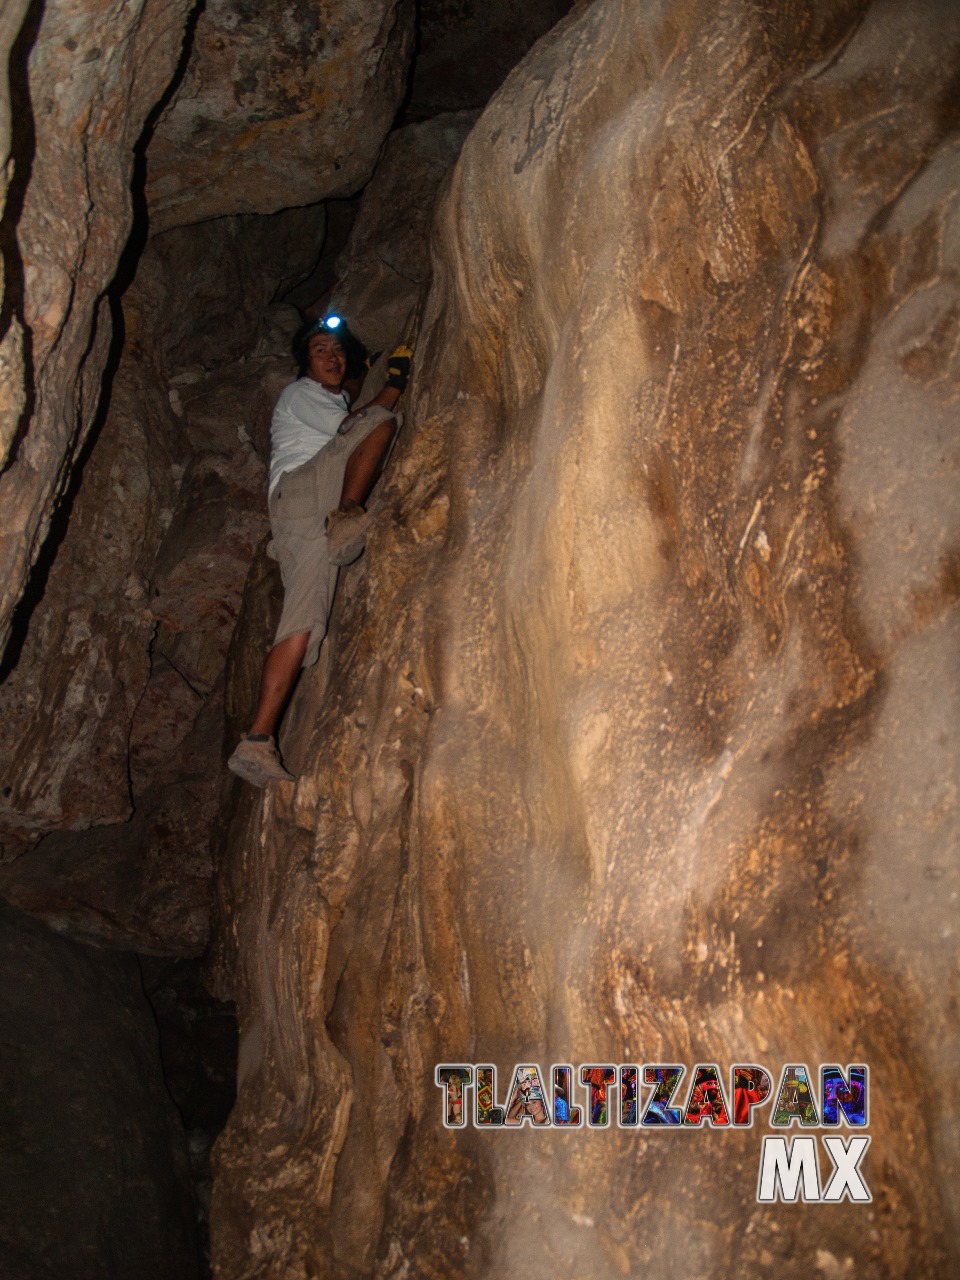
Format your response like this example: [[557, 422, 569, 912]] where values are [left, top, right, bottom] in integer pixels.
[[147, 0, 413, 230]]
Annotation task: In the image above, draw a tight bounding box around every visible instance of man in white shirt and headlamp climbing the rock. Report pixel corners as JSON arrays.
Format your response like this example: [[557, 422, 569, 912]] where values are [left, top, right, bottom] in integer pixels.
[[227, 316, 412, 787]]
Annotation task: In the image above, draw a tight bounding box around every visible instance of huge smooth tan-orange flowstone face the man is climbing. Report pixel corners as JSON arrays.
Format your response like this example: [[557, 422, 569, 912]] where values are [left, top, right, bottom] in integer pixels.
[[214, 0, 960, 1280]]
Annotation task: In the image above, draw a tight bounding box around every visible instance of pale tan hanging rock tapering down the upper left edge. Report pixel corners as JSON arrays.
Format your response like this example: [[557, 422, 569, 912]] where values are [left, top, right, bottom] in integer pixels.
[[0, 0, 191, 648]]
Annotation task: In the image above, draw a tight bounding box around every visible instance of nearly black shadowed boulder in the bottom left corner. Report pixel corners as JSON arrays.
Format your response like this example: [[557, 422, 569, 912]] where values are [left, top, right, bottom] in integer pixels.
[[0, 904, 200, 1280]]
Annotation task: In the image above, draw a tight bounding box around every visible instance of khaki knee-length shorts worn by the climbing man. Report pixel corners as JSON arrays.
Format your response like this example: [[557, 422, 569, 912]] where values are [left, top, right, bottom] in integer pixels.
[[268, 404, 403, 667]]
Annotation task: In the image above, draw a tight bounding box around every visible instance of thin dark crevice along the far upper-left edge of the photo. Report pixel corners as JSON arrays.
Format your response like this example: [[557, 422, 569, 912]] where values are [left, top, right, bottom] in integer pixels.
[[0, 0, 44, 476]]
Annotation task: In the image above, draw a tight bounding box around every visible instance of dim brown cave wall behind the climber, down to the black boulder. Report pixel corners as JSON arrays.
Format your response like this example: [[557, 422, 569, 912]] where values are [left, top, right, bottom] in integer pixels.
[[0, 197, 325, 955]]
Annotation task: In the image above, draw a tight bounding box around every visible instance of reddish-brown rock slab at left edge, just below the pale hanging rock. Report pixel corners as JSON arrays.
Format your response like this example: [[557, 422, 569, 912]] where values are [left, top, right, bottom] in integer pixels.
[[0, 358, 183, 856]]
